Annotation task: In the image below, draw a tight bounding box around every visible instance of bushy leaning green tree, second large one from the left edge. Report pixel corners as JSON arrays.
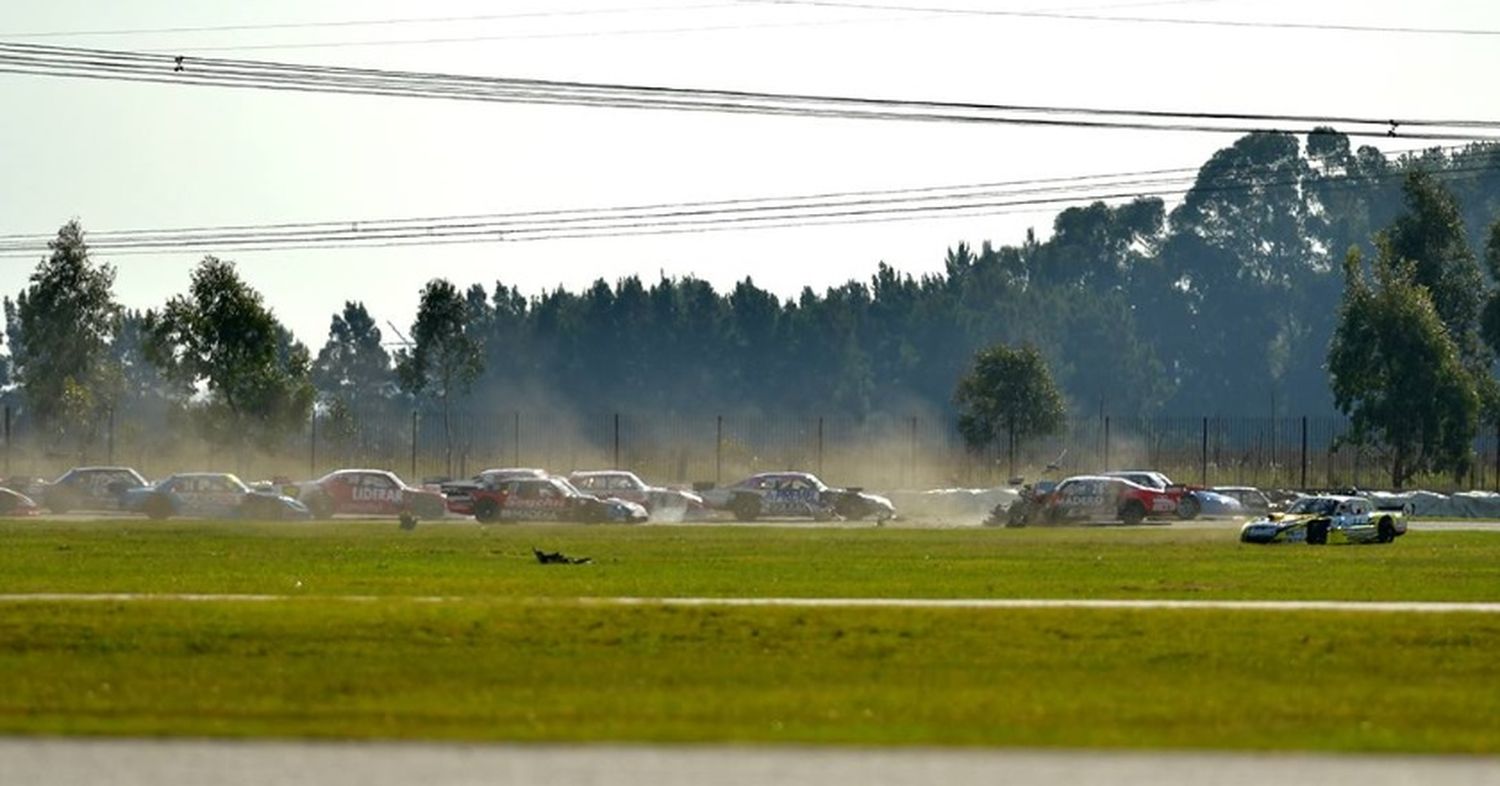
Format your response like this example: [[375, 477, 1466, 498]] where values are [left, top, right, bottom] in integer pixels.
[[144, 257, 315, 446]]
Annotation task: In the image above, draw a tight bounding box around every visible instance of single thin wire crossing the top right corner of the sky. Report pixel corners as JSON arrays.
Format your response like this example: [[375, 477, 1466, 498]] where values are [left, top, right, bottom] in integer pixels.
[[741, 0, 1500, 38]]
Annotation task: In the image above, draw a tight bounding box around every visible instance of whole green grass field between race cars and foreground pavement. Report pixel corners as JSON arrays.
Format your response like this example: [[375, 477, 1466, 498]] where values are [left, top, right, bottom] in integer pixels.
[[0, 521, 1500, 753]]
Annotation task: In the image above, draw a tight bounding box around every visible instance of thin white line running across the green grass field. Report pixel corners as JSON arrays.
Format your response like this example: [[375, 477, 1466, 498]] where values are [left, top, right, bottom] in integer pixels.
[[0, 593, 1500, 614]]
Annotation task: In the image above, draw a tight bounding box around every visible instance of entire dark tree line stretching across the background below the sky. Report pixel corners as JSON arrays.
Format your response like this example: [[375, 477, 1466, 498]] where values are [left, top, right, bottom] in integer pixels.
[[0, 129, 1500, 486]]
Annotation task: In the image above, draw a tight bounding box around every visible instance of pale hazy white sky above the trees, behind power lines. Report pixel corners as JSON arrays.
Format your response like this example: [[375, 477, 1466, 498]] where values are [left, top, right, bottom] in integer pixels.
[[0, 0, 1500, 351]]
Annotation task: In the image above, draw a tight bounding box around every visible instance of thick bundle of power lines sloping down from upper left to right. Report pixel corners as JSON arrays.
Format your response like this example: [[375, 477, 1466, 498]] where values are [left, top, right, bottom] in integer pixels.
[[0, 42, 1500, 141]]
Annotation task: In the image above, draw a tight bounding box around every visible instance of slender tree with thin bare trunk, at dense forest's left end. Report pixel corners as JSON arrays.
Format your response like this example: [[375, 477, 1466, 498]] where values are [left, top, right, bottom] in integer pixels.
[[396, 279, 485, 476]]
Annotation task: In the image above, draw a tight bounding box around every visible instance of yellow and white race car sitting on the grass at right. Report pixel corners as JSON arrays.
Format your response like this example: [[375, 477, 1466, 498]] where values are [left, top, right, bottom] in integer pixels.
[[1239, 495, 1406, 546]]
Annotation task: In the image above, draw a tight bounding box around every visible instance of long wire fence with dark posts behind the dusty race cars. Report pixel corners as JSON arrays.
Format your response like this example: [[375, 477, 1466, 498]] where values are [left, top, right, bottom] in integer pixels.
[[0, 408, 1500, 491]]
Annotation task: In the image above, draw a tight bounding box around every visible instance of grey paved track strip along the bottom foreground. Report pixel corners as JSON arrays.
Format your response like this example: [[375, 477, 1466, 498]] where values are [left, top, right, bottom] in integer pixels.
[[0, 738, 1500, 786]]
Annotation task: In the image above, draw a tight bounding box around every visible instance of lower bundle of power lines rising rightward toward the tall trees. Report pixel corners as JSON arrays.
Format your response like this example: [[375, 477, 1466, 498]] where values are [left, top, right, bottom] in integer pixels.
[[0, 149, 1500, 258]]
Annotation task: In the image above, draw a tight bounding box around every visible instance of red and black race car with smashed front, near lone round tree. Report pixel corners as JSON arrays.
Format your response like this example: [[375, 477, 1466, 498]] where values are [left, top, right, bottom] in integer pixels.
[[1005, 476, 1178, 527]]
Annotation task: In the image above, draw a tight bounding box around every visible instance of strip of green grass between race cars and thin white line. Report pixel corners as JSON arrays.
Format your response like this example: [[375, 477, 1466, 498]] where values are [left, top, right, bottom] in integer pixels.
[[0, 521, 1500, 602]]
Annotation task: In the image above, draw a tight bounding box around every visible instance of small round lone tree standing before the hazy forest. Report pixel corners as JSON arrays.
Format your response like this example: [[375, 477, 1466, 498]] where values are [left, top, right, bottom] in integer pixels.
[[954, 344, 1067, 474]]
